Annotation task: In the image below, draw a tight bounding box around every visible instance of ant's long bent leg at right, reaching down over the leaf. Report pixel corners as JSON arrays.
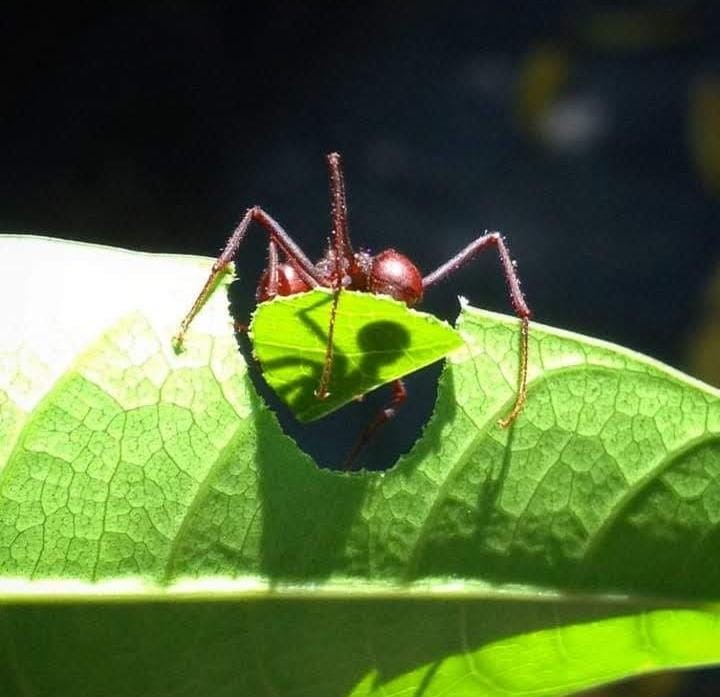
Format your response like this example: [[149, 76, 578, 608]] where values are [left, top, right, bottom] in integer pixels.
[[423, 232, 532, 428]]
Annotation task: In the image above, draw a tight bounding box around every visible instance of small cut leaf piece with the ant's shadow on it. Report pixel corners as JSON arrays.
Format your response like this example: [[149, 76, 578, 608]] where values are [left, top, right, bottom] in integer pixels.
[[250, 290, 462, 422]]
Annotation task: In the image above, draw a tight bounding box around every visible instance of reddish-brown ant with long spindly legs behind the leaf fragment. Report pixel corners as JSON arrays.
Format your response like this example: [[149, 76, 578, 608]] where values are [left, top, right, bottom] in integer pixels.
[[175, 153, 531, 469]]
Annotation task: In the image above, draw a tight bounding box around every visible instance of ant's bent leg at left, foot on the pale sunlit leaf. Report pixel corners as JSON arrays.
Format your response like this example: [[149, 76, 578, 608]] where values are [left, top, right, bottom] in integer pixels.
[[173, 206, 326, 351]]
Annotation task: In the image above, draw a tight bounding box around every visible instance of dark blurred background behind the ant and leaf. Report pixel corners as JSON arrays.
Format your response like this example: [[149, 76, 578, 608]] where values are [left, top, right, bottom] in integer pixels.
[[0, 0, 720, 695]]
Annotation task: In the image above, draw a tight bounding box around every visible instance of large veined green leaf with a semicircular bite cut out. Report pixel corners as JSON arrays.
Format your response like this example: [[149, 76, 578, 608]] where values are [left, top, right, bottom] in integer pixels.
[[0, 237, 720, 697]]
